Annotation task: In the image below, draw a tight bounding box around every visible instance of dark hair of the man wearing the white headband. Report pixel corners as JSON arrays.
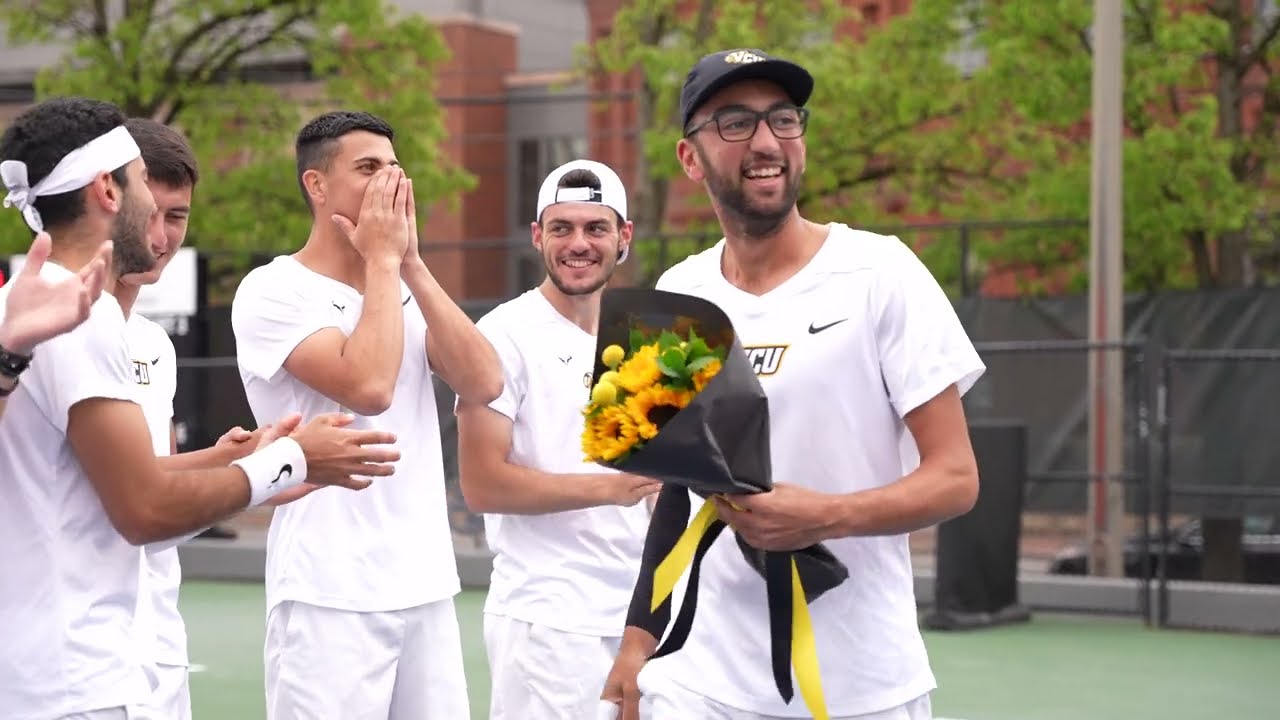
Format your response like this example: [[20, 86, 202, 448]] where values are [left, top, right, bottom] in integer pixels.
[[0, 97, 128, 228]]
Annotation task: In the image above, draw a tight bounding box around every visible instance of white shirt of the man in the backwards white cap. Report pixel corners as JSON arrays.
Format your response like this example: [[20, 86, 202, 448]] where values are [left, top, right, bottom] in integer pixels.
[[476, 288, 649, 637]]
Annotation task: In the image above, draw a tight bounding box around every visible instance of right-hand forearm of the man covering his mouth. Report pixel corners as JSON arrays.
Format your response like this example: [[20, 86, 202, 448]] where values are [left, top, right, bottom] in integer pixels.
[[404, 261, 502, 404]]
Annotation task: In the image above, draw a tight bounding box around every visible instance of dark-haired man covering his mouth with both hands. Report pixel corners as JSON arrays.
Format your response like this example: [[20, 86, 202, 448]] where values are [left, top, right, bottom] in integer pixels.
[[232, 111, 502, 720]]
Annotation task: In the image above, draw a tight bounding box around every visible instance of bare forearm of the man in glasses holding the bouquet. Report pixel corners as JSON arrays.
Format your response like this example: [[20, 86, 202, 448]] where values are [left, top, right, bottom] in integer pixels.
[[835, 462, 978, 537]]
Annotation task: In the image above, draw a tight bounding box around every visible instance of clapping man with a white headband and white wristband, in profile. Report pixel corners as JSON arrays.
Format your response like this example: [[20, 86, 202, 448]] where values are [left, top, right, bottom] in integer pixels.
[[0, 97, 397, 720]]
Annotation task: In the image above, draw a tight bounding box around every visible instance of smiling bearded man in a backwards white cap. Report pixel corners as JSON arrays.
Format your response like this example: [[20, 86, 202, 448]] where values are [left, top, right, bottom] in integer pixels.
[[457, 160, 659, 720]]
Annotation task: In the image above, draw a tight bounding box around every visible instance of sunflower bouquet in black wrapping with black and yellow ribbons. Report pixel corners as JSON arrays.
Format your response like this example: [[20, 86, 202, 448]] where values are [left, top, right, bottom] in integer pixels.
[[582, 288, 849, 717]]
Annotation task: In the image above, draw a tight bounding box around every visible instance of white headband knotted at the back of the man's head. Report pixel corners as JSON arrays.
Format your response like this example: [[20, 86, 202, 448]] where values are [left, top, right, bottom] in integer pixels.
[[0, 126, 142, 232]]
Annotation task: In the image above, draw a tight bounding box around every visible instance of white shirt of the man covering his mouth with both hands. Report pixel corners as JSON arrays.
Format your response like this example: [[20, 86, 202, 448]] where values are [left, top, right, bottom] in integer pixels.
[[232, 256, 461, 611]]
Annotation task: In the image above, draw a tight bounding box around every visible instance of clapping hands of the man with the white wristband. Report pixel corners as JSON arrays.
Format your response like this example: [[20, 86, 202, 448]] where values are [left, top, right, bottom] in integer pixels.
[[289, 413, 401, 489]]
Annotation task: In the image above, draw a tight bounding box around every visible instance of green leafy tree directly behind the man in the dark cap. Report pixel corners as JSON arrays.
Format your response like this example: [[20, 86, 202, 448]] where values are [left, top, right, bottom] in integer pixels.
[[584, 0, 1001, 288]]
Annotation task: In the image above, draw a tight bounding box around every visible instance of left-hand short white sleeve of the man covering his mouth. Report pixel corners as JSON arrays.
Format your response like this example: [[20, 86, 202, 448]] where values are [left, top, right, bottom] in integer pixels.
[[232, 265, 339, 380]]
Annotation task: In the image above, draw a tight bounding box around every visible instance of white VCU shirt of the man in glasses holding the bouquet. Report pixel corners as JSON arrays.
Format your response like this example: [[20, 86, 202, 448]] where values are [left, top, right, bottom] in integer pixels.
[[648, 224, 984, 717]]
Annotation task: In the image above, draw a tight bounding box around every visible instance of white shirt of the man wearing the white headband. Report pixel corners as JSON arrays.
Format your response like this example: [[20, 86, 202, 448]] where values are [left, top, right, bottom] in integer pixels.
[[0, 263, 150, 720]]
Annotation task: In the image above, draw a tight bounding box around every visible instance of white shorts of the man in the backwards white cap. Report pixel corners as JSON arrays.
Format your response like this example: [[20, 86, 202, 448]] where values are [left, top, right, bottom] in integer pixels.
[[484, 612, 622, 720]]
